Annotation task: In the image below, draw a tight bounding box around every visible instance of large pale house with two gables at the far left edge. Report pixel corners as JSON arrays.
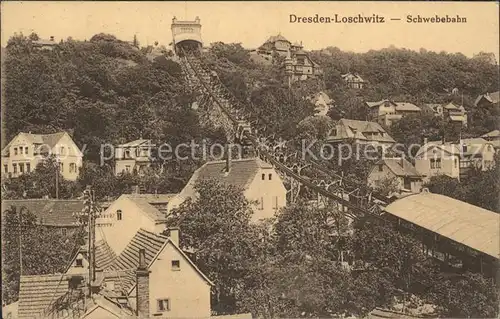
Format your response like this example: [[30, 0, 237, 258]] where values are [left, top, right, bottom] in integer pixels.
[[2, 132, 83, 181]]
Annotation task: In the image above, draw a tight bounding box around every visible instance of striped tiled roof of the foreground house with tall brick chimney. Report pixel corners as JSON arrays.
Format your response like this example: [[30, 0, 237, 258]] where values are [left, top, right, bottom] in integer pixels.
[[105, 229, 212, 292]]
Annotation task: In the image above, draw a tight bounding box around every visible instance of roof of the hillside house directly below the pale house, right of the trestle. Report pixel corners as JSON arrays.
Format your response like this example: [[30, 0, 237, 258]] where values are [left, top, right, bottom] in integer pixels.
[[329, 119, 395, 143]]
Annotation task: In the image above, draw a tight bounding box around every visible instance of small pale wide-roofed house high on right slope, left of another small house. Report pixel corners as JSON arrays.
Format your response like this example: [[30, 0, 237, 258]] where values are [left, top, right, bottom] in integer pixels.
[[366, 99, 421, 126]]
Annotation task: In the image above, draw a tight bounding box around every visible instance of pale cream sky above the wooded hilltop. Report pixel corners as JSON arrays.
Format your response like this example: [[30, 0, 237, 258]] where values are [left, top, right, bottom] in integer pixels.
[[1, 1, 500, 60]]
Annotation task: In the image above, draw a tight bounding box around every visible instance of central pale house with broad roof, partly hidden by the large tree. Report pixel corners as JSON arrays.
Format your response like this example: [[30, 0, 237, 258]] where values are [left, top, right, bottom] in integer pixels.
[[168, 158, 286, 222]]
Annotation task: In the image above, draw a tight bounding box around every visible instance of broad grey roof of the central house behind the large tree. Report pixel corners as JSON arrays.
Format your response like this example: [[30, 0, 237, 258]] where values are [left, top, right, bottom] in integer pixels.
[[174, 158, 273, 204]]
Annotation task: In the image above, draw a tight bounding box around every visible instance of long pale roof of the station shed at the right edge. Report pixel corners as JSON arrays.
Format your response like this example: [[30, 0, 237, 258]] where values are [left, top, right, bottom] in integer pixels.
[[385, 192, 500, 258]]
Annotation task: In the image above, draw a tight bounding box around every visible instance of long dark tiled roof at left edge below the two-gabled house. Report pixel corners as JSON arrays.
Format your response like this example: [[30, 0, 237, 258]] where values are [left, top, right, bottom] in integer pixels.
[[2, 199, 84, 227]]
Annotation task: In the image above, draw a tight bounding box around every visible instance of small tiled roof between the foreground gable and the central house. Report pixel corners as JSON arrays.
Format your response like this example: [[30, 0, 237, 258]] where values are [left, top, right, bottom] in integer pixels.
[[122, 194, 176, 222]]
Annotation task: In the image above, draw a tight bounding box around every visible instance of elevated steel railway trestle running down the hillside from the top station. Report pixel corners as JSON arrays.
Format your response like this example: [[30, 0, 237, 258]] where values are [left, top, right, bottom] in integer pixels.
[[181, 51, 386, 219]]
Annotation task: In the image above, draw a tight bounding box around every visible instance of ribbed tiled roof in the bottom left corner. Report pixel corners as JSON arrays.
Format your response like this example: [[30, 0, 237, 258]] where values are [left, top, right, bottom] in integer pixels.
[[18, 274, 68, 319]]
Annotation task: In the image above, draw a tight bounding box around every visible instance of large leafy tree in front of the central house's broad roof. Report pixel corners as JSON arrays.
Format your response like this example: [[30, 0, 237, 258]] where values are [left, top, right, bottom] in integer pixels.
[[167, 181, 260, 313]]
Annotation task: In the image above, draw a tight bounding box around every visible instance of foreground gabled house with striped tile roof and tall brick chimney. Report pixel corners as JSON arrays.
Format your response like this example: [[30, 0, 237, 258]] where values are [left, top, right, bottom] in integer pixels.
[[104, 229, 213, 318]]
